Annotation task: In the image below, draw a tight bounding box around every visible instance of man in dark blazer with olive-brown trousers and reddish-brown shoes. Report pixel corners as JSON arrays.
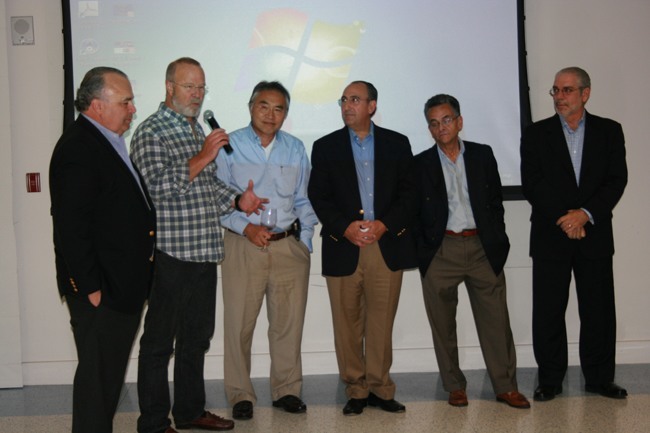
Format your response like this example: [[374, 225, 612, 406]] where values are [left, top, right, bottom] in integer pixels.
[[415, 94, 530, 408]]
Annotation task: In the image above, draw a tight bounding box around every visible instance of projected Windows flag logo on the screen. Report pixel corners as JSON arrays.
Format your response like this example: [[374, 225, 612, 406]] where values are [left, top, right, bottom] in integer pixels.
[[237, 9, 364, 104]]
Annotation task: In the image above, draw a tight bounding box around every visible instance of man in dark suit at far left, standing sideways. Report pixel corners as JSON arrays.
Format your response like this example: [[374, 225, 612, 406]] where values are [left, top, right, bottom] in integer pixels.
[[50, 67, 156, 433]]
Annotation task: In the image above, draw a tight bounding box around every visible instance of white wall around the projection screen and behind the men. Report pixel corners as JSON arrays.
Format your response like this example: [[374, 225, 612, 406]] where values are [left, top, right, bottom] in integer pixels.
[[0, 0, 650, 386]]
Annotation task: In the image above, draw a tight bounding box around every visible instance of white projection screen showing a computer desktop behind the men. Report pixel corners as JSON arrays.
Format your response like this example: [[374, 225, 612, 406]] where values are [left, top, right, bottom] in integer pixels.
[[70, 0, 521, 186]]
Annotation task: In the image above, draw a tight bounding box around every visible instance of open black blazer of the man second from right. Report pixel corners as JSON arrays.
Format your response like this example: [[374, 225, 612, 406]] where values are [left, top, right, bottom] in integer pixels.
[[415, 141, 510, 276]]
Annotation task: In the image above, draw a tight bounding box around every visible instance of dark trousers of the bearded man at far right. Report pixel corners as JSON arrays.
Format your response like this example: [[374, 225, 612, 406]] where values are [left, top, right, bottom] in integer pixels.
[[533, 254, 616, 386]]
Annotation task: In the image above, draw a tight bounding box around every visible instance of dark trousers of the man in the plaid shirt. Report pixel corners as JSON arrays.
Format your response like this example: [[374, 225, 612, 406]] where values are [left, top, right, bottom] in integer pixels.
[[138, 251, 217, 433]]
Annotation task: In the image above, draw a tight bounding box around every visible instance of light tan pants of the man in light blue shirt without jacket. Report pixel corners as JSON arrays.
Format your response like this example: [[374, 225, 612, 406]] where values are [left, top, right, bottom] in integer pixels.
[[221, 231, 311, 405]]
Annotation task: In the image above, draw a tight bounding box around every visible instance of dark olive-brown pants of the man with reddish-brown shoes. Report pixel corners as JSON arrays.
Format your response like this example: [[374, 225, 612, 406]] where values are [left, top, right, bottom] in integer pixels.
[[422, 236, 517, 394]]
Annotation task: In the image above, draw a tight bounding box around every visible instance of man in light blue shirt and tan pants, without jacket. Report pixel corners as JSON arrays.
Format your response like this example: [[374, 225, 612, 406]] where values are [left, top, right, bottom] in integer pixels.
[[217, 81, 318, 420]]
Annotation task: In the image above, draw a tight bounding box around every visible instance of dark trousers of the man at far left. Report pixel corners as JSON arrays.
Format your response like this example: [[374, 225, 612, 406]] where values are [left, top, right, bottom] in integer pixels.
[[66, 296, 140, 433]]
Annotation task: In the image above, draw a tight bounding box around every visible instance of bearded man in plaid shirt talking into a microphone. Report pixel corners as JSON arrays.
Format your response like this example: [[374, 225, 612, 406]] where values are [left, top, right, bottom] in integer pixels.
[[131, 57, 261, 433]]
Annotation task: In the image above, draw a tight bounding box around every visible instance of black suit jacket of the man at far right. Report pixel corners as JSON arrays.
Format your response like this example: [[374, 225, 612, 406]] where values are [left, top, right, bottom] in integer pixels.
[[521, 113, 627, 259]]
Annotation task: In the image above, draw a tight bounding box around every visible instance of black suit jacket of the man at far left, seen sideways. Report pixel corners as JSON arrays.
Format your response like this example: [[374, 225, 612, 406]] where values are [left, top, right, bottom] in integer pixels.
[[50, 116, 156, 313]]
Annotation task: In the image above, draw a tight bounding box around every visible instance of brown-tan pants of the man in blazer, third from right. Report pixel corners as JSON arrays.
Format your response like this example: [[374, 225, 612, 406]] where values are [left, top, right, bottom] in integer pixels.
[[326, 243, 402, 400]]
